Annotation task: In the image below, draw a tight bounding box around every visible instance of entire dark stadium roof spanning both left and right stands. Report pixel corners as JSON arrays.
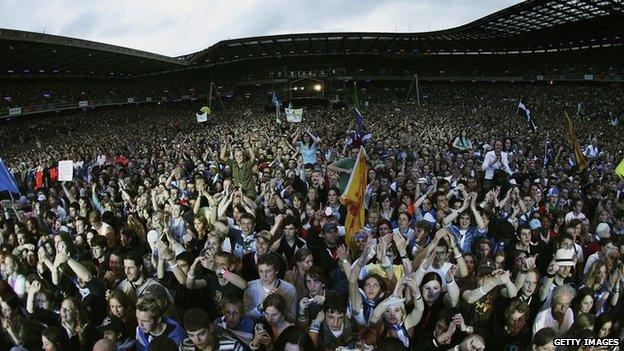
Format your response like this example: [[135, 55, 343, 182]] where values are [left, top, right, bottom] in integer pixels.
[[0, 0, 624, 76]]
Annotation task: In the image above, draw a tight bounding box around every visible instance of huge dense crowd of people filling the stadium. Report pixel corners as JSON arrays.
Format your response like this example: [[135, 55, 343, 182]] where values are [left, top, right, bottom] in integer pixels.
[[0, 80, 624, 351]]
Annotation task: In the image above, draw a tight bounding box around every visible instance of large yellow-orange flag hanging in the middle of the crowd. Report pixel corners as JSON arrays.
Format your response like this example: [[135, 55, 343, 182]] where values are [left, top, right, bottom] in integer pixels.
[[340, 147, 368, 249]]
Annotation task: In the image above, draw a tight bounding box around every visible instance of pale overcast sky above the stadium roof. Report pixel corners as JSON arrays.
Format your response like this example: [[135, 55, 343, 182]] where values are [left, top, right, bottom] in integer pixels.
[[0, 0, 521, 56]]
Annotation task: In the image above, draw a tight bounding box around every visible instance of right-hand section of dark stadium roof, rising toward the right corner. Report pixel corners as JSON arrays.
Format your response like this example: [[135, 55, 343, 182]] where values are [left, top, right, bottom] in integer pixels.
[[188, 0, 624, 64]]
